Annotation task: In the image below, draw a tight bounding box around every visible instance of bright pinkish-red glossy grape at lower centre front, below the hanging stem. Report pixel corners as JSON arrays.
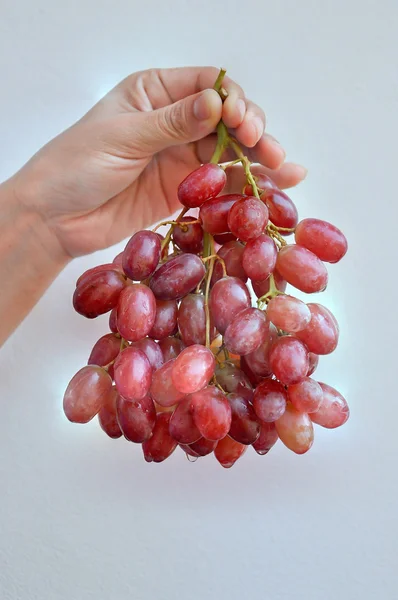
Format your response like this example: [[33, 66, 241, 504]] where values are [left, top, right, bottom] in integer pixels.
[[171, 344, 216, 394]]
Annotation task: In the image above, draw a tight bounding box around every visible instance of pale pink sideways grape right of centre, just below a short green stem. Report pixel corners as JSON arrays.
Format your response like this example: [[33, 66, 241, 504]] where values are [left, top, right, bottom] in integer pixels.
[[267, 295, 311, 333]]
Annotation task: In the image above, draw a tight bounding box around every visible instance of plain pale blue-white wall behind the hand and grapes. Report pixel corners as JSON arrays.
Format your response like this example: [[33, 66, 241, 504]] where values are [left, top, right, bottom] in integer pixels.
[[0, 0, 398, 600]]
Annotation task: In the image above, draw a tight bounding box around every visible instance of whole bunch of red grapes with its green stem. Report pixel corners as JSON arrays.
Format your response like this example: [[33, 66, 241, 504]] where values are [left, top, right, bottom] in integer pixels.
[[64, 72, 349, 467]]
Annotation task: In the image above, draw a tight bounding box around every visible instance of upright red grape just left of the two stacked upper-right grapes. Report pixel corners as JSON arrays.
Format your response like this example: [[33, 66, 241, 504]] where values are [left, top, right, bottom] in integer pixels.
[[242, 233, 278, 281]]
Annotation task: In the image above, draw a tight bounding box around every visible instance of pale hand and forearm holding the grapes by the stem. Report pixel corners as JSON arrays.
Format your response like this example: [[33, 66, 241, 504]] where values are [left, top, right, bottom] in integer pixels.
[[0, 67, 306, 345]]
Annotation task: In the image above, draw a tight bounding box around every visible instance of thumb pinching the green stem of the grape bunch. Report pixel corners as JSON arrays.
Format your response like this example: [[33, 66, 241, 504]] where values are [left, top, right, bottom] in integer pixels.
[[136, 89, 222, 154]]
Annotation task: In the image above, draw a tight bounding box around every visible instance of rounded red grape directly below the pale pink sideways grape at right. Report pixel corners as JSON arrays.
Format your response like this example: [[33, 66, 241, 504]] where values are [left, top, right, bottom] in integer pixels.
[[269, 336, 309, 385]]
